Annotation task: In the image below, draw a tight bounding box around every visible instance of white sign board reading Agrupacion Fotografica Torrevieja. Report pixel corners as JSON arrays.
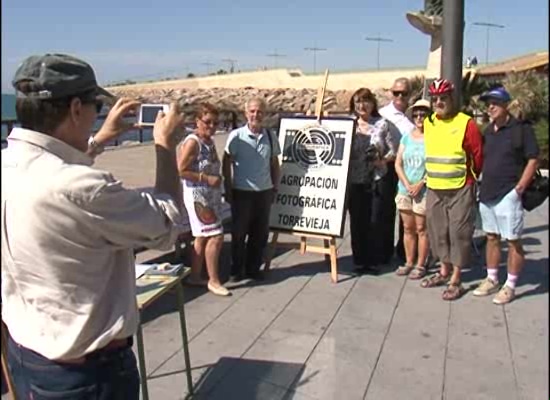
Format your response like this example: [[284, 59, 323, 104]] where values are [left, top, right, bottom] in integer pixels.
[[269, 117, 355, 237]]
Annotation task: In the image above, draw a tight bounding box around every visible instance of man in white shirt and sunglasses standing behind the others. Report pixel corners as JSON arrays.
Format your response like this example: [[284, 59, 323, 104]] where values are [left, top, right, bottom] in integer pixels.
[[378, 78, 414, 260]]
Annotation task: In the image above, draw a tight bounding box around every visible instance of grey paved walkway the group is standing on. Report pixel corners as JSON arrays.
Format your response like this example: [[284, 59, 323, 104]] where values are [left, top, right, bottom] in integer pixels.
[[2, 138, 548, 400]]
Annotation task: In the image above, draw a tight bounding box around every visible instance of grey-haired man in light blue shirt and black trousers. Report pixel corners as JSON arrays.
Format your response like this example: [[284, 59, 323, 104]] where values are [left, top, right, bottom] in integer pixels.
[[223, 98, 281, 282]]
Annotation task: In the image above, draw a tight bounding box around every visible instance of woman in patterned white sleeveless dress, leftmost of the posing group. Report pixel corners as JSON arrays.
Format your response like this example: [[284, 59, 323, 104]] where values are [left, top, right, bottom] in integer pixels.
[[178, 103, 231, 296]]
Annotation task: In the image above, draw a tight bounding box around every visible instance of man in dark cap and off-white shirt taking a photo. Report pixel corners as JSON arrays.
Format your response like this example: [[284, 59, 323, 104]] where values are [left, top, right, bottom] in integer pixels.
[[2, 54, 183, 400]]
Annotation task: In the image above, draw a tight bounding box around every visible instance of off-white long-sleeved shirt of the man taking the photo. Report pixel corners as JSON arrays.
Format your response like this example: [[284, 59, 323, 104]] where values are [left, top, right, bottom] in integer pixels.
[[2, 128, 181, 360]]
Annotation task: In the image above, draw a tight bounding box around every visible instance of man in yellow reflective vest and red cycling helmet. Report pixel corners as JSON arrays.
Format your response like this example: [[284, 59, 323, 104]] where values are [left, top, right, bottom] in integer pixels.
[[421, 79, 483, 300]]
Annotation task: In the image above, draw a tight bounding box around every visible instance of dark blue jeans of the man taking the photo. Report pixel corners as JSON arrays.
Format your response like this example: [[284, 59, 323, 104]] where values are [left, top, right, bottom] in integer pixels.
[[8, 337, 140, 400]]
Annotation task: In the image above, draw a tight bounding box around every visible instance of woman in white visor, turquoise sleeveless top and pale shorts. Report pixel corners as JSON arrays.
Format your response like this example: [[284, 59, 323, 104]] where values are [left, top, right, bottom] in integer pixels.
[[395, 99, 431, 279]]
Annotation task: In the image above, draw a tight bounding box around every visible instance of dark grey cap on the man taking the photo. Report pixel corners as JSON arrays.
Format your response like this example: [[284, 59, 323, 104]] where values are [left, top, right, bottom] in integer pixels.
[[12, 54, 114, 100]]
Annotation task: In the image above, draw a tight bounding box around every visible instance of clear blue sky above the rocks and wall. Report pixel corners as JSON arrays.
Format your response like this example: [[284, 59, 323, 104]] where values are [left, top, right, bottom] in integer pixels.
[[2, 0, 548, 93]]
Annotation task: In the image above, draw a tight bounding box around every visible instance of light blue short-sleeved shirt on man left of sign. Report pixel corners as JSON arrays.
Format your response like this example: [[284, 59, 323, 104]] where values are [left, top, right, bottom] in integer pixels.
[[225, 125, 281, 191]]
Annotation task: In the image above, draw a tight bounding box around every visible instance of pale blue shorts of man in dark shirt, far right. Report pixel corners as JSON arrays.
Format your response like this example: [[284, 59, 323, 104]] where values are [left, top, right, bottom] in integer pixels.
[[479, 188, 523, 240]]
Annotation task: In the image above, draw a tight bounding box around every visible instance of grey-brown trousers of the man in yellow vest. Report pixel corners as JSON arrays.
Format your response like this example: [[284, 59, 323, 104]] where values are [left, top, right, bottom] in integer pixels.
[[426, 185, 475, 267]]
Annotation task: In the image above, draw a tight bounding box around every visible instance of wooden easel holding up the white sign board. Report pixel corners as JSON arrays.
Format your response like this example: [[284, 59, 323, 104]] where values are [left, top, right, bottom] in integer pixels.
[[264, 69, 338, 283]]
